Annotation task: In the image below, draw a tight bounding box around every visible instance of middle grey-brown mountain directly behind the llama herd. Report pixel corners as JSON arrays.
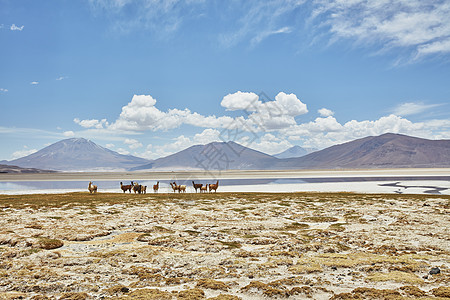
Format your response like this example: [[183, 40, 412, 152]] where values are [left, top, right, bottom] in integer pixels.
[[132, 142, 278, 170]]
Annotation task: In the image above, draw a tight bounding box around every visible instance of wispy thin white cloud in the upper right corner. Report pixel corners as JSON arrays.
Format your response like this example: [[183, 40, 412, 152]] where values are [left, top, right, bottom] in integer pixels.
[[312, 0, 450, 58]]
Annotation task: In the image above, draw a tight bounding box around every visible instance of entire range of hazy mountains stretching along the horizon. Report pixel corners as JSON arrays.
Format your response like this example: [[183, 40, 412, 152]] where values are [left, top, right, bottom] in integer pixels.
[[1, 133, 450, 172]]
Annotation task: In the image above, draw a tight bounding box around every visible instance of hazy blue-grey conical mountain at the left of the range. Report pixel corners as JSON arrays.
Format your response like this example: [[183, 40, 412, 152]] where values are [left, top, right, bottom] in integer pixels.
[[8, 138, 150, 171]]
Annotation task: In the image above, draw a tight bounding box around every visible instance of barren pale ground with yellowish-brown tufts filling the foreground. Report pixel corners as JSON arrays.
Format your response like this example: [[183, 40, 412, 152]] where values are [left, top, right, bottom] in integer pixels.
[[0, 193, 450, 299]]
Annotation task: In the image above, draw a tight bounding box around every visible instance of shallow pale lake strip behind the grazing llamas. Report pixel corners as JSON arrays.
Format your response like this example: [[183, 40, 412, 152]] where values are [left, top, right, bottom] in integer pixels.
[[0, 176, 450, 194]]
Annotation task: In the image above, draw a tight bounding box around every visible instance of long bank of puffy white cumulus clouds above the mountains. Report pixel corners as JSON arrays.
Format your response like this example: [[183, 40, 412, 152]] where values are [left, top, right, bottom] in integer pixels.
[[74, 91, 450, 158]]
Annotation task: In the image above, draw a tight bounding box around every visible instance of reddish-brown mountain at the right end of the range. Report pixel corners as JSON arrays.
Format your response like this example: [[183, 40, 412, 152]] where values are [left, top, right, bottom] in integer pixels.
[[274, 133, 450, 169]]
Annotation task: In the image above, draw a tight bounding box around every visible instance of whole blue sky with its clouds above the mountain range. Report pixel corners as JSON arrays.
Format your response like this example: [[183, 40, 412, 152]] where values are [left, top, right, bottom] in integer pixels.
[[0, 0, 450, 160]]
